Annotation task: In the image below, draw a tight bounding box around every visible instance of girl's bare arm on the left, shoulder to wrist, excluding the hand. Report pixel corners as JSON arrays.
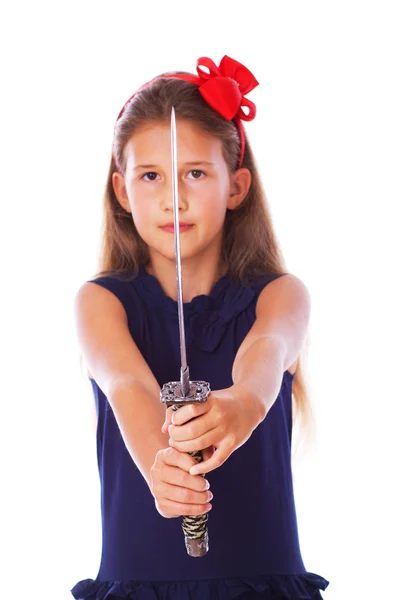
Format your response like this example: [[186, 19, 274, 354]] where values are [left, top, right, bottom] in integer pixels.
[[74, 282, 172, 485]]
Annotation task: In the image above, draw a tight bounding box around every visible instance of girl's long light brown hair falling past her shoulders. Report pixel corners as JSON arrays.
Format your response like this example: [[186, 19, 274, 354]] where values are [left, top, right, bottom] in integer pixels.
[[80, 77, 313, 464]]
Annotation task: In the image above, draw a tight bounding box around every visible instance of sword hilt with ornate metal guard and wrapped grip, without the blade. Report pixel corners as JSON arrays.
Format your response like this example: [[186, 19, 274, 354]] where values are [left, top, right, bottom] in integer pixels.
[[160, 380, 211, 557]]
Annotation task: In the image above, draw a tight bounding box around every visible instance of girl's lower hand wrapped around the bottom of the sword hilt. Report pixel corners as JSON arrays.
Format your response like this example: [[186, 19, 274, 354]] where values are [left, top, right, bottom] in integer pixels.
[[150, 448, 212, 519]]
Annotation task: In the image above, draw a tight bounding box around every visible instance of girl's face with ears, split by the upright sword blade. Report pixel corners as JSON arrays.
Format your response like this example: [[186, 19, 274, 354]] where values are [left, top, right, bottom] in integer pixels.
[[113, 119, 251, 262]]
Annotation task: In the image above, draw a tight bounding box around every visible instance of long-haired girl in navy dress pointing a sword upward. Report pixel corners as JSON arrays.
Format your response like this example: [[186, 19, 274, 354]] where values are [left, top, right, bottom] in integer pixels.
[[71, 56, 328, 600]]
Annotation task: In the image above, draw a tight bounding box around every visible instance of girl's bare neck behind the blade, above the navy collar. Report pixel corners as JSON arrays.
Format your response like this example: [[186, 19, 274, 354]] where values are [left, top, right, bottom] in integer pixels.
[[146, 255, 227, 302]]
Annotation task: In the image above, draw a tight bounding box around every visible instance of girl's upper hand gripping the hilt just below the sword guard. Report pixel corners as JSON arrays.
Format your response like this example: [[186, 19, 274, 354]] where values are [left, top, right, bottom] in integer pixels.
[[162, 385, 265, 475]]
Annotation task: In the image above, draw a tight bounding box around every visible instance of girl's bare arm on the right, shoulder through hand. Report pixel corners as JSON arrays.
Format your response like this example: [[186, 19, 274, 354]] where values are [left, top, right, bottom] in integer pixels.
[[163, 274, 310, 474]]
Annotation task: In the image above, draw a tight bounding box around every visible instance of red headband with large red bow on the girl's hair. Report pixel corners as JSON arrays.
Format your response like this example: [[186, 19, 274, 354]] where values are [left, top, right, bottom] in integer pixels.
[[113, 55, 259, 171]]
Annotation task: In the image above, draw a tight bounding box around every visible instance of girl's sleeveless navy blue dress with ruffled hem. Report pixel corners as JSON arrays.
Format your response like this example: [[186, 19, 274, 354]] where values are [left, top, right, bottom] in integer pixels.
[[71, 268, 329, 600]]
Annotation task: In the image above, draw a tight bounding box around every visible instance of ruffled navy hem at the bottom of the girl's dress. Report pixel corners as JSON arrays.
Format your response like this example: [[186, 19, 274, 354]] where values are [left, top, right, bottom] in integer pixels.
[[71, 572, 329, 600]]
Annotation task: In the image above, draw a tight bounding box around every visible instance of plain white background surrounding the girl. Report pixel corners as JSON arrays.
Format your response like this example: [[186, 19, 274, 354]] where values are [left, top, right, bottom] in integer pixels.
[[0, 0, 400, 600]]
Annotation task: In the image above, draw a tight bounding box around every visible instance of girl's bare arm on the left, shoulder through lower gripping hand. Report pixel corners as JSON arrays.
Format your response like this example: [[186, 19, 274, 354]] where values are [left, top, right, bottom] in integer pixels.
[[75, 282, 211, 518]]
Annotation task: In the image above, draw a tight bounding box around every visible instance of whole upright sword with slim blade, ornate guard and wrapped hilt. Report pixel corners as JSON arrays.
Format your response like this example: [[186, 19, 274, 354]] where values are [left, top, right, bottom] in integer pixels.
[[160, 107, 211, 556]]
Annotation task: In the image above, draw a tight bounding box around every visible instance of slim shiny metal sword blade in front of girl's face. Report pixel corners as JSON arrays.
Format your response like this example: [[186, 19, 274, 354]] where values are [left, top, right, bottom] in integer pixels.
[[171, 107, 190, 397]]
